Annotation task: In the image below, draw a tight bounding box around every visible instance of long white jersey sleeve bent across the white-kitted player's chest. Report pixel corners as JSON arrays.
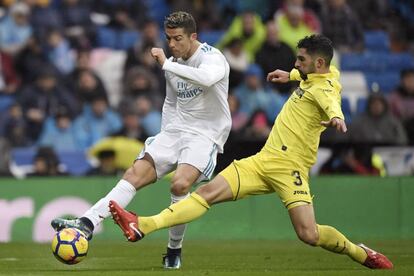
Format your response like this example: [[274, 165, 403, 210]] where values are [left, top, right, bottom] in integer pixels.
[[162, 53, 226, 87]]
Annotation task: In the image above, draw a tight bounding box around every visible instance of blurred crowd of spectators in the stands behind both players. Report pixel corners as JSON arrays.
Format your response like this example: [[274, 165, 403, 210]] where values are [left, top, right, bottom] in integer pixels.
[[0, 0, 414, 175]]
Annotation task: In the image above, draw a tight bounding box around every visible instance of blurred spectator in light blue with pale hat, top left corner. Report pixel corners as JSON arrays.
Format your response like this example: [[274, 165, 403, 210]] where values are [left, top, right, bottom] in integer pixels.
[[0, 2, 32, 56]]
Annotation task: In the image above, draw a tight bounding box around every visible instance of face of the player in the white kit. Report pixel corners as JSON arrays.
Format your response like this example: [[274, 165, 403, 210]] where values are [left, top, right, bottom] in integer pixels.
[[165, 28, 197, 58]]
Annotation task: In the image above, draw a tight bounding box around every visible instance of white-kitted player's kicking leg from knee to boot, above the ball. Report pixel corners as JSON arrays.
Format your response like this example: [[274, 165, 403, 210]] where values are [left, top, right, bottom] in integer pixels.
[[51, 154, 157, 239]]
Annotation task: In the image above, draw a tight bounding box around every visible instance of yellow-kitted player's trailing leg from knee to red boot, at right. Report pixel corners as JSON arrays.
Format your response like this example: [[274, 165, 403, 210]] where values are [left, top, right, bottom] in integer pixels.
[[289, 204, 393, 269]]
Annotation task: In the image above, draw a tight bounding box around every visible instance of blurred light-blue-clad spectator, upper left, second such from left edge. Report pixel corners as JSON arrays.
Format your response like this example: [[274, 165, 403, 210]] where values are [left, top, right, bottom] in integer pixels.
[[46, 29, 75, 75]]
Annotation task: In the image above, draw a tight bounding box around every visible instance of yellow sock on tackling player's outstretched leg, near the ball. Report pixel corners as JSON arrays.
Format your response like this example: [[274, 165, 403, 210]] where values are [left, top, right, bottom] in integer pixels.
[[139, 193, 210, 235]]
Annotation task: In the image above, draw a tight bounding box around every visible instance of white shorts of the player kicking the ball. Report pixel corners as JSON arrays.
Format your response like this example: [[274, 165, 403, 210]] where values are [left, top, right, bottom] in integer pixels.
[[137, 131, 218, 182]]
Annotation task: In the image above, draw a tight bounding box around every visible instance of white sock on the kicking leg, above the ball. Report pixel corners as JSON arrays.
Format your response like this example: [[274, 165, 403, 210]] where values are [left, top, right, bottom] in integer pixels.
[[83, 179, 136, 227]]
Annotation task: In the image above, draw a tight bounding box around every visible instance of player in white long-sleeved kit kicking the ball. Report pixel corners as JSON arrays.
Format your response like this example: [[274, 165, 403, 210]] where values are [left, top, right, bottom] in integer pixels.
[[51, 11, 231, 269]]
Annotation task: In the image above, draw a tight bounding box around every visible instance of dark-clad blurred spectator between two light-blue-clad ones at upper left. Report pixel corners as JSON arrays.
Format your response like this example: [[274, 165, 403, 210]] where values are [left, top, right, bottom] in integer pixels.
[[15, 36, 51, 84]]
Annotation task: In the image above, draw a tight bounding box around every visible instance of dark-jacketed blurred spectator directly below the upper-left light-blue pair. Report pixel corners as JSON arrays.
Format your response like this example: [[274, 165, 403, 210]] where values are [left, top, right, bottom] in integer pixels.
[[19, 68, 79, 141]]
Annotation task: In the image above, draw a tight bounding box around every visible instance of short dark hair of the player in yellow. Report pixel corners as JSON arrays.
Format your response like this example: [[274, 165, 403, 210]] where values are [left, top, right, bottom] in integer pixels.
[[297, 34, 333, 66]]
